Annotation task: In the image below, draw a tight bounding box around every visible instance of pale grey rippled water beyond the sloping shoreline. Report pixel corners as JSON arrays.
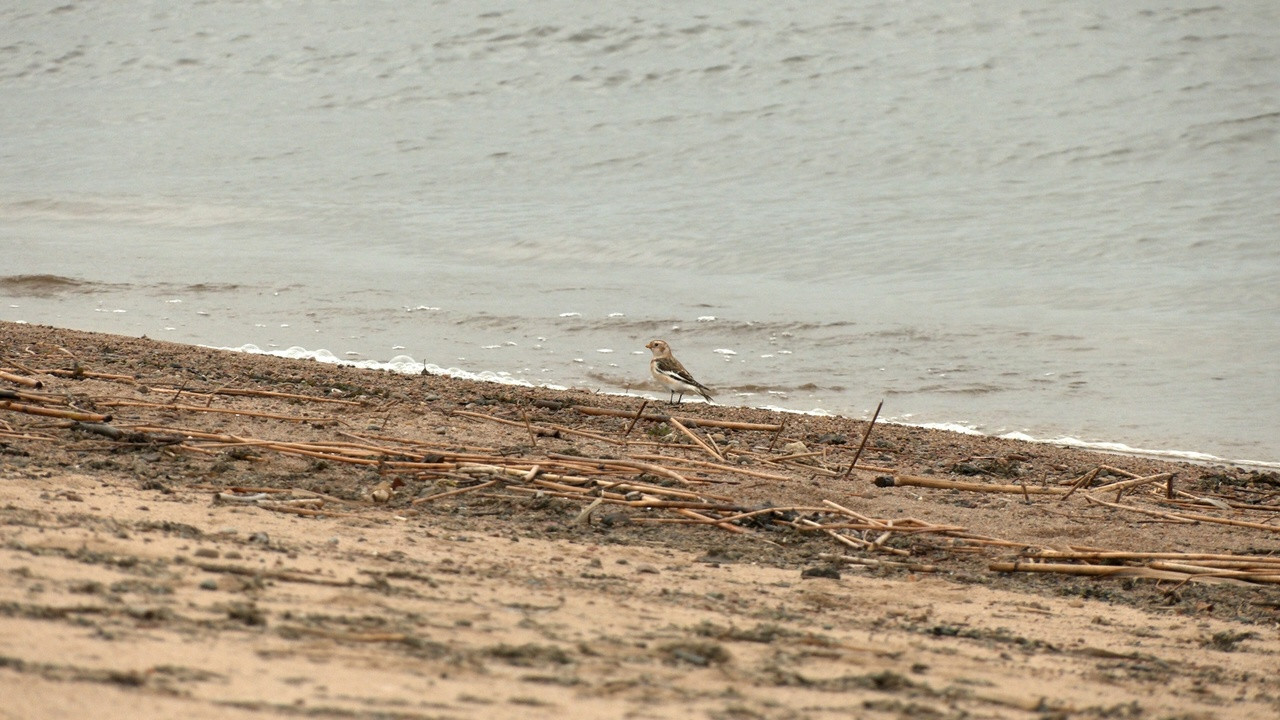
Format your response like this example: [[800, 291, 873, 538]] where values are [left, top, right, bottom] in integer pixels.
[[0, 0, 1280, 462]]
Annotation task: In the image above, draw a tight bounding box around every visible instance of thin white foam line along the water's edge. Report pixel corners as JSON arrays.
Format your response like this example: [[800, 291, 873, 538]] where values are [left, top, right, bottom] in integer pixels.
[[220, 345, 1280, 470]]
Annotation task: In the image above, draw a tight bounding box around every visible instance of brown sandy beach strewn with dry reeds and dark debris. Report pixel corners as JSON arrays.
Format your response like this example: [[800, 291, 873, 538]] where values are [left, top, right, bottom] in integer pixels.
[[0, 323, 1280, 720]]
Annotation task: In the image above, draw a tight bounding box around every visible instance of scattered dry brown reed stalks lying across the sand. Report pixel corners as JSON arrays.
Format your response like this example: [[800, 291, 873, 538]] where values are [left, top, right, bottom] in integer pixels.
[[0, 351, 1280, 584]]
